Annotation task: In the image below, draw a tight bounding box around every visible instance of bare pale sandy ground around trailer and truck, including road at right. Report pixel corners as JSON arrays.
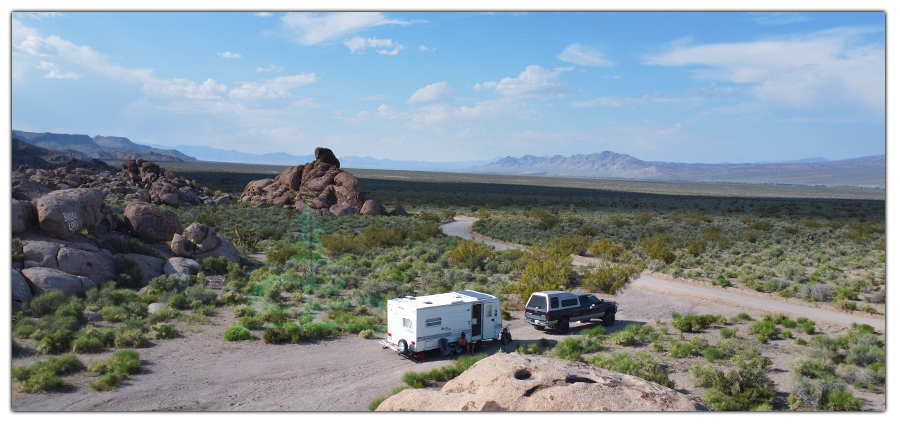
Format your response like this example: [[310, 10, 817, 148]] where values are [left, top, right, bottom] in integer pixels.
[[11, 220, 885, 411]]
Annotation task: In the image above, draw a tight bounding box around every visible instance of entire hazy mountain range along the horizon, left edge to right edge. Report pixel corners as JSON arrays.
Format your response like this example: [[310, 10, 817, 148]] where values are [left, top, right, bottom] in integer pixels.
[[12, 130, 886, 188]]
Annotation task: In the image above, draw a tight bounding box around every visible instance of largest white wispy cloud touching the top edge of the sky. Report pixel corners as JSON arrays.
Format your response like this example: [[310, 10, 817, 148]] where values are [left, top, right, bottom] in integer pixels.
[[281, 12, 409, 46]]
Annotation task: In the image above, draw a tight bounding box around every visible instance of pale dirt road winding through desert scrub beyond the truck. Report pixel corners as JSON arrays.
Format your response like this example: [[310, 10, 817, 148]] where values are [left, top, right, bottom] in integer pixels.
[[441, 216, 885, 333]]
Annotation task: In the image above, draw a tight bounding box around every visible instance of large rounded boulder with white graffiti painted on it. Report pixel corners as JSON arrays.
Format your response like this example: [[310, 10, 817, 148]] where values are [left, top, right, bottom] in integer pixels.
[[37, 188, 118, 239]]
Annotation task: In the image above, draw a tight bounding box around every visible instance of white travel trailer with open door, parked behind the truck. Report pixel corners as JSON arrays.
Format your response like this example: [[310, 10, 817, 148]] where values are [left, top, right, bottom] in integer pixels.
[[381, 290, 508, 360]]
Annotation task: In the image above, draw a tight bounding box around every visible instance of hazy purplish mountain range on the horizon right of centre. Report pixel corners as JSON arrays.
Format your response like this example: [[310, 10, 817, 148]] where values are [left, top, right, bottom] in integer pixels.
[[466, 151, 886, 188]]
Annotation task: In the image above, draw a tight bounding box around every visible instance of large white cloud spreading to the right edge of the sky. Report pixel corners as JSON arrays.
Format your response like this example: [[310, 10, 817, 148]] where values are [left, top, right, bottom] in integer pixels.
[[647, 28, 885, 111]]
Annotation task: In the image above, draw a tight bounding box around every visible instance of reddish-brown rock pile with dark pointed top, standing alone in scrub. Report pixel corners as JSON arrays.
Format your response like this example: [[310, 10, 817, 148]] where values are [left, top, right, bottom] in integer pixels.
[[240, 148, 386, 215]]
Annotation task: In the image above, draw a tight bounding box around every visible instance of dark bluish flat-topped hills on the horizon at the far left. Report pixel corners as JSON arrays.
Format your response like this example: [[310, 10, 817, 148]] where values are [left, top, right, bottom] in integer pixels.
[[12, 130, 197, 161]]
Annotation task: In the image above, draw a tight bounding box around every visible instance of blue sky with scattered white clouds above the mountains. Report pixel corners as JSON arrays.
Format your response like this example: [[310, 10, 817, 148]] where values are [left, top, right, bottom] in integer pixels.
[[11, 12, 885, 163]]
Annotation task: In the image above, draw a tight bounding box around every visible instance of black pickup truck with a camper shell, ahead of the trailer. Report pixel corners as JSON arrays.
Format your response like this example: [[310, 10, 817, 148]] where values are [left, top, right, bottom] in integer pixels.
[[525, 291, 619, 333]]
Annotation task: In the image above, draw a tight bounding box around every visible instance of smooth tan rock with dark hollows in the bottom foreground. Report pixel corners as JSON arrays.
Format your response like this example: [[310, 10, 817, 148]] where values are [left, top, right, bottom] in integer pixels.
[[377, 353, 710, 411]]
